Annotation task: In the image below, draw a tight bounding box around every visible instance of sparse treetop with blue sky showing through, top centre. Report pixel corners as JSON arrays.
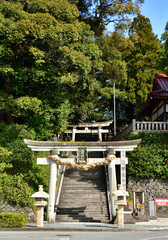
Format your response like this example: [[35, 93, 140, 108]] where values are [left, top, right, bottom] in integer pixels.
[[77, 0, 144, 36]]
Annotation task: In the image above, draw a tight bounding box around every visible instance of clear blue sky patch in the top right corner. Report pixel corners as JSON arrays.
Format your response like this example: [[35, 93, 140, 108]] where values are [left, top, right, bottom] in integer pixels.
[[141, 0, 168, 39]]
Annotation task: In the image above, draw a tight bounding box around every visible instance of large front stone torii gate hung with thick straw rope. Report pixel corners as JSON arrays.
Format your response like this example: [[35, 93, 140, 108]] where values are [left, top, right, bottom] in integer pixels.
[[24, 139, 141, 222]]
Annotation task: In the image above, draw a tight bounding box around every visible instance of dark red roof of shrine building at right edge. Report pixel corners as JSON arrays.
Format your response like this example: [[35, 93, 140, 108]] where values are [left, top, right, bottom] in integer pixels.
[[138, 72, 168, 116]]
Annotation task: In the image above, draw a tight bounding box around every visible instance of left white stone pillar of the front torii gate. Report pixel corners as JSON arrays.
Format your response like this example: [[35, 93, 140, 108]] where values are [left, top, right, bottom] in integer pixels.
[[47, 150, 58, 223]]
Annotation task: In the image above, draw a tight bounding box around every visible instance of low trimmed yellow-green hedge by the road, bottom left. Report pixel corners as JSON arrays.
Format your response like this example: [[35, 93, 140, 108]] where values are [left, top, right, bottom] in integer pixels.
[[0, 213, 28, 228]]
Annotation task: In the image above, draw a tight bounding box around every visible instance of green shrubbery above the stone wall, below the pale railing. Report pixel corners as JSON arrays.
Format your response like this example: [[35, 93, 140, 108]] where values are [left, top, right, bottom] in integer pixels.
[[127, 133, 168, 179]]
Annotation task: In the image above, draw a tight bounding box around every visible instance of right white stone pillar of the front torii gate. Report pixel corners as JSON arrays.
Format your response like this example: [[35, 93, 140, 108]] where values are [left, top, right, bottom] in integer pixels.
[[107, 149, 117, 218]]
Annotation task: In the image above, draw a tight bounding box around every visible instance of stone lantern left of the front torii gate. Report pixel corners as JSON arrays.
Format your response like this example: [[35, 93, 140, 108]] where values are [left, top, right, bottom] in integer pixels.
[[31, 185, 49, 227]]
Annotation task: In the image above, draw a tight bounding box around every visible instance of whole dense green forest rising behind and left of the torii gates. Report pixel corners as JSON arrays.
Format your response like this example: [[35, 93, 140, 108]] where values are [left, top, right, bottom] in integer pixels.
[[0, 0, 168, 205]]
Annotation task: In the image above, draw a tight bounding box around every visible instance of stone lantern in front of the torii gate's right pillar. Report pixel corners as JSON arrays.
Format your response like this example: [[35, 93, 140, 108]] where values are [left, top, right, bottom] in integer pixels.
[[112, 184, 129, 228]]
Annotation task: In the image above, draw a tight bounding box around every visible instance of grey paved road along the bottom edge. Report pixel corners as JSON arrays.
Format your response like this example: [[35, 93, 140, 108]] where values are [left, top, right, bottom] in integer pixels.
[[0, 230, 168, 240]]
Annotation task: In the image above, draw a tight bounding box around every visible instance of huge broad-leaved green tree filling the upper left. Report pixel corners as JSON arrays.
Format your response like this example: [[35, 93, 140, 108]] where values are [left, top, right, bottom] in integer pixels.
[[0, 0, 102, 139]]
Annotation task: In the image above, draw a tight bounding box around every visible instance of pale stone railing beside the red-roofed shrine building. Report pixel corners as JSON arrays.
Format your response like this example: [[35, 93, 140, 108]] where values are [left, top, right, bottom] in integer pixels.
[[132, 119, 168, 132]]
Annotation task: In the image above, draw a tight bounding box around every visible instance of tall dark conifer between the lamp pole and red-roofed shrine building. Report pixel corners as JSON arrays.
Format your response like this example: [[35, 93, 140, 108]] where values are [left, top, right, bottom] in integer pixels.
[[126, 15, 160, 109]]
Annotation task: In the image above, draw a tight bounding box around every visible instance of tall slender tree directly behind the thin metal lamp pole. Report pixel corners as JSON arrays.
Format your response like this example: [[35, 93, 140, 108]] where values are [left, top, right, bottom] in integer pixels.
[[97, 31, 132, 123]]
